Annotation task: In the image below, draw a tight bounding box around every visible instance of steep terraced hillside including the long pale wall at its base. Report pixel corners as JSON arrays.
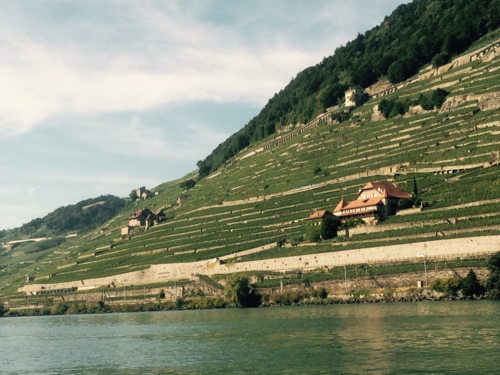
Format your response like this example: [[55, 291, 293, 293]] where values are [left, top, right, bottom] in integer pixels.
[[4, 7, 500, 304]]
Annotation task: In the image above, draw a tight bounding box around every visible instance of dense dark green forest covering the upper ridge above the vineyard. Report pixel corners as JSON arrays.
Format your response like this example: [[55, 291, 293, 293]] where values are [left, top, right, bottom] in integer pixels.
[[198, 0, 500, 176]]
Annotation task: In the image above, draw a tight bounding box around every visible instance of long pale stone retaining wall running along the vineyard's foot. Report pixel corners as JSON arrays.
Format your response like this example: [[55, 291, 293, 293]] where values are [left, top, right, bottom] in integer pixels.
[[19, 236, 500, 293]]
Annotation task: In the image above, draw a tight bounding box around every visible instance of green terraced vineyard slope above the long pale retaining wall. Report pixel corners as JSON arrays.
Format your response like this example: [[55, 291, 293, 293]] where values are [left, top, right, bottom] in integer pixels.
[[0, 41, 500, 300]]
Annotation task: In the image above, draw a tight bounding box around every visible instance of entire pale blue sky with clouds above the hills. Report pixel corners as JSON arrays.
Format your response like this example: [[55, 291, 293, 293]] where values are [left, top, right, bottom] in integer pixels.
[[0, 0, 402, 229]]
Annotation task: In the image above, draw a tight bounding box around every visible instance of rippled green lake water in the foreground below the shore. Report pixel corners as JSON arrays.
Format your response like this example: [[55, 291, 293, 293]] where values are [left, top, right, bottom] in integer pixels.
[[0, 301, 500, 374]]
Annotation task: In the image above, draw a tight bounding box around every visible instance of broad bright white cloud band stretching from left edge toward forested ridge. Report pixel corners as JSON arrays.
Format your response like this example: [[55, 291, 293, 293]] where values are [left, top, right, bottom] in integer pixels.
[[0, 1, 311, 134]]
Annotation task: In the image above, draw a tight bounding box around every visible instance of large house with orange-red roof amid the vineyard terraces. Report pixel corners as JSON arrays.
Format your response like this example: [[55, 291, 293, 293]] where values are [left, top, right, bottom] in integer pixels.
[[333, 182, 411, 223]]
